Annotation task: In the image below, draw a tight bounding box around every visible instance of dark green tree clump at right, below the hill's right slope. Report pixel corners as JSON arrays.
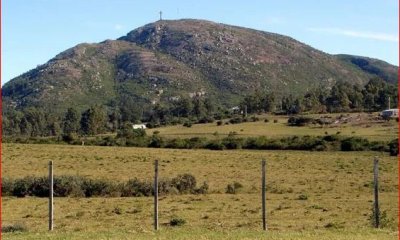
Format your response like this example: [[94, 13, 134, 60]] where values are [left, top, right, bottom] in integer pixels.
[[241, 78, 397, 114]]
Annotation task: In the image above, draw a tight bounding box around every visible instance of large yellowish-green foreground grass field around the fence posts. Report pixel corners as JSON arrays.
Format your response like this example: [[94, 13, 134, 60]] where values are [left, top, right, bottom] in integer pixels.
[[2, 144, 398, 240]]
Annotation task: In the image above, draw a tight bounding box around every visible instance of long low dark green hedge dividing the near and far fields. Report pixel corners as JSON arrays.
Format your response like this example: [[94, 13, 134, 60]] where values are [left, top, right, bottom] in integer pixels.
[[3, 134, 398, 156]]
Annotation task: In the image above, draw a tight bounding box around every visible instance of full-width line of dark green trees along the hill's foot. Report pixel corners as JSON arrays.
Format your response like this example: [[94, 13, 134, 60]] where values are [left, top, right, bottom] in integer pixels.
[[2, 78, 397, 137]]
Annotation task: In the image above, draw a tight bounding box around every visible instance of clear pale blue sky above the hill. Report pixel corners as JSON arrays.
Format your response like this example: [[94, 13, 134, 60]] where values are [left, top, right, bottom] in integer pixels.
[[1, 0, 399, 85]]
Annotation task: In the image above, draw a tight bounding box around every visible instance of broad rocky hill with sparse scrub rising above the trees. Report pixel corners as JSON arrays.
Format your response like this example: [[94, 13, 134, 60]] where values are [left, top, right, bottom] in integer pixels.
[[2, 20, 397, 112]]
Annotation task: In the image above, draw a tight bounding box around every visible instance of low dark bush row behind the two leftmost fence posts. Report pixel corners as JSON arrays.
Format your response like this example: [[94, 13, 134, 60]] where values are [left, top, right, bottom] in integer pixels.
[[2, 174, 208, 197]]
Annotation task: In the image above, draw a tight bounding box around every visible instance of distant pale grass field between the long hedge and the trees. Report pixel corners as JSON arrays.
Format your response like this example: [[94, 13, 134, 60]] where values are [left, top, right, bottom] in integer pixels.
[[147, 113, 398, 140]]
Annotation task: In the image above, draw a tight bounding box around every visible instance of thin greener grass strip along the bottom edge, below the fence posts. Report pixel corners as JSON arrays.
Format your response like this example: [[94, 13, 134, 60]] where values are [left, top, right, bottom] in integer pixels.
[[3, 229, 397, 240]]
